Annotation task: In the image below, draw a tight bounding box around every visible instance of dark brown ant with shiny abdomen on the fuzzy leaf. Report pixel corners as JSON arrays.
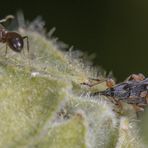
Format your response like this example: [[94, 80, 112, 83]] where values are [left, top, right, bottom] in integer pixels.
[[0, 15, 29, 55]]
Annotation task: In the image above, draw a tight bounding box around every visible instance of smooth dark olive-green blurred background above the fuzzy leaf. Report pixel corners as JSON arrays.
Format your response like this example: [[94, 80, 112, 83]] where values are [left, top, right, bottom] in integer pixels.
[[0, 0, 148, 81]]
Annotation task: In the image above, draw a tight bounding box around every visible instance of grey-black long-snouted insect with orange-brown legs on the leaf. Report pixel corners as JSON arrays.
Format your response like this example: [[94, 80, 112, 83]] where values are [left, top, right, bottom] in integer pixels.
[[82, 74, 148, 112]]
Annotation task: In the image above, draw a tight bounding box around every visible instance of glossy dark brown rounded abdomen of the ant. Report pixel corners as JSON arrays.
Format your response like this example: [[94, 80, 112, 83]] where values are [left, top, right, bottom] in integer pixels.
[[6, 32, 24, 52]]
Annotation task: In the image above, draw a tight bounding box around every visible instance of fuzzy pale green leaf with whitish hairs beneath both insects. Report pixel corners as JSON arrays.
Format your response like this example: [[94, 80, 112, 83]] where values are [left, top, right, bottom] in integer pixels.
[[0, 26, 145, 148]]
